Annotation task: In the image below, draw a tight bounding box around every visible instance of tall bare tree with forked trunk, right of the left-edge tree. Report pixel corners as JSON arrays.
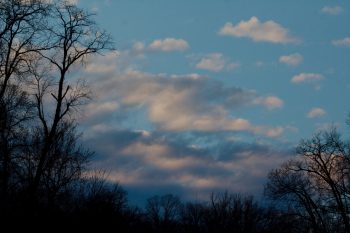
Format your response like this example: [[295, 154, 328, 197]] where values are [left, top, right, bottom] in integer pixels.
[[30, 1, 111, 200]]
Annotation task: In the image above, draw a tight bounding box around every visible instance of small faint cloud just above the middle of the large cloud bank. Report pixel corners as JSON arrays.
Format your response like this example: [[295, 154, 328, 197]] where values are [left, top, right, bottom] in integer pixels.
[[196, 53, 239, 72]]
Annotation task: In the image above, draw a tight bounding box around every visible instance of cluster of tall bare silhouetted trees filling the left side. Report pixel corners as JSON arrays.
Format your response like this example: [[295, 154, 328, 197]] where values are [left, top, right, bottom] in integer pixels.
[[0, 0, 112, 218]]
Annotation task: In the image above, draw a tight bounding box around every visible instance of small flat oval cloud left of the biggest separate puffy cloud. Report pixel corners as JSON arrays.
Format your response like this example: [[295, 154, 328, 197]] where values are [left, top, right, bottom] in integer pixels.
[[148, 38, 190, 52]]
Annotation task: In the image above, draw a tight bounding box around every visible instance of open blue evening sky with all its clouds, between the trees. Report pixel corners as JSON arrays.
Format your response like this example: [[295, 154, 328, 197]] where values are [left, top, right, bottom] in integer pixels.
[[70, 0, 350, 202]]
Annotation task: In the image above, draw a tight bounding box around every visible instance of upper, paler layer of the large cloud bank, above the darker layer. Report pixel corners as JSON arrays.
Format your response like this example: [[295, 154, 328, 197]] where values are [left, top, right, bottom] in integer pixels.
[[85, 53, 282, 136]]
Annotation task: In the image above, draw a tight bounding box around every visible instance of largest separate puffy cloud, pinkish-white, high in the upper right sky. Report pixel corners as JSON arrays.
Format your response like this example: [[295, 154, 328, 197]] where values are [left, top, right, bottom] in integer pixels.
[[219, 16, 298, 44]]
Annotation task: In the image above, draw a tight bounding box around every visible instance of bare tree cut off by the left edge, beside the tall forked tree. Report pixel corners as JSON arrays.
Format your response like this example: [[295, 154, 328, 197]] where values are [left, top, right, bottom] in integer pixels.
[[0, 0, 48, 209]]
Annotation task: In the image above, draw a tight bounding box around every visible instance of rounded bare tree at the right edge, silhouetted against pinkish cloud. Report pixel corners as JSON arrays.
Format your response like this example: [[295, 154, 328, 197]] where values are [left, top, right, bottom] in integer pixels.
[[266, 128, 350, 232]]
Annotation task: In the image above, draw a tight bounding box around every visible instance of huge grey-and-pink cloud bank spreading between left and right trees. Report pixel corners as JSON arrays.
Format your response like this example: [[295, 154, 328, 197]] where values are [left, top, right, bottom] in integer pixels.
[[80, 43, 289, 203]]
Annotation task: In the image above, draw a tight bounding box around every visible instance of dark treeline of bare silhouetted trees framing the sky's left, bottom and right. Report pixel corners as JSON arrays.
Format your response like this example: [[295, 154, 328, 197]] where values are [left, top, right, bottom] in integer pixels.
[[0, 0, 350, 233]]
